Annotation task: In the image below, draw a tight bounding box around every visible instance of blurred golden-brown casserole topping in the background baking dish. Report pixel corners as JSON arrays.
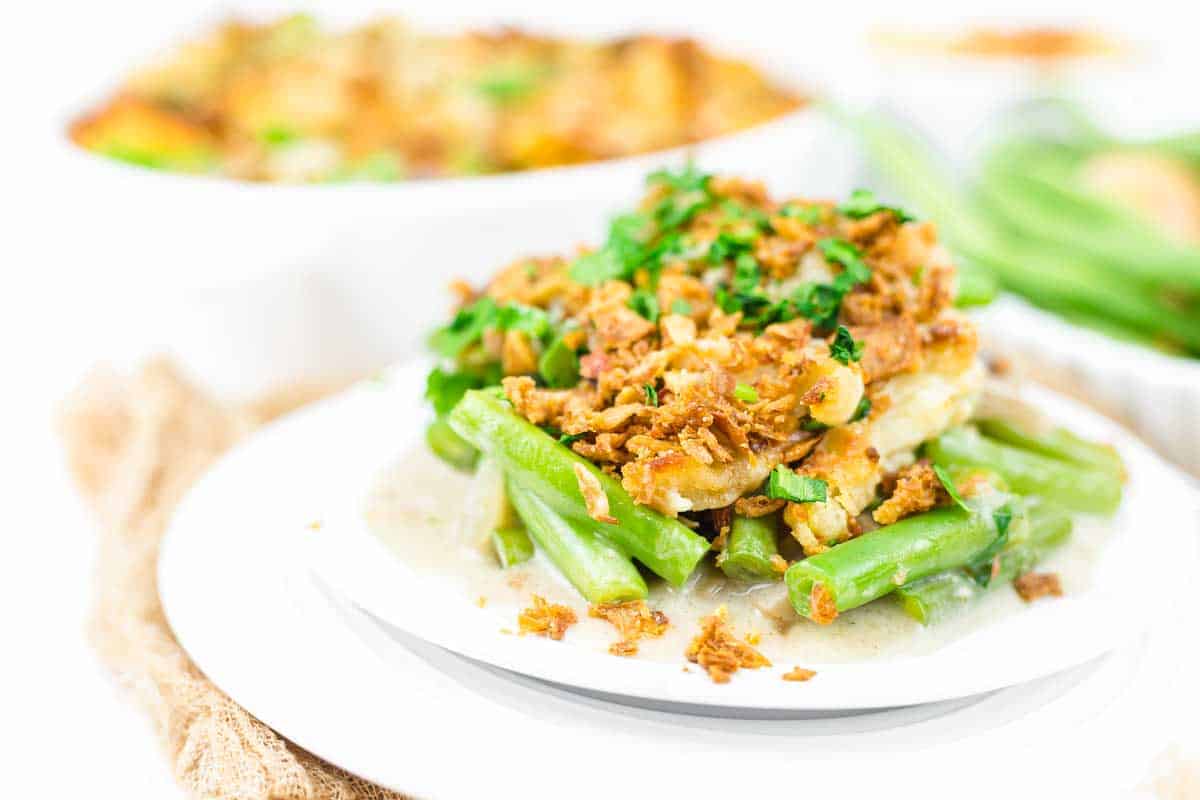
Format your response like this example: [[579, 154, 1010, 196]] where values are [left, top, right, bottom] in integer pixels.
[[70, 14, 805, 181]]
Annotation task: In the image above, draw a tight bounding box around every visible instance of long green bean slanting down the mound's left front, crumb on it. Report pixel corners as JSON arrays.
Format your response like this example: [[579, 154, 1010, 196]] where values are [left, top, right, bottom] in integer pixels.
[[448, 390, 709, 587]]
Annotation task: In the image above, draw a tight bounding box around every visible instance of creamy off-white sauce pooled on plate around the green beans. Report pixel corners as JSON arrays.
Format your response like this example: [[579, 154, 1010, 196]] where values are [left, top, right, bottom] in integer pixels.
[[366, 447, 1110, 667]]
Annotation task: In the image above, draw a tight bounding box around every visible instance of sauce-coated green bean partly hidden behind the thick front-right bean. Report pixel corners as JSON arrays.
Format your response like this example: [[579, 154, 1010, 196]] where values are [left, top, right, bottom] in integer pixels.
[[895, 503, 1074, 625]]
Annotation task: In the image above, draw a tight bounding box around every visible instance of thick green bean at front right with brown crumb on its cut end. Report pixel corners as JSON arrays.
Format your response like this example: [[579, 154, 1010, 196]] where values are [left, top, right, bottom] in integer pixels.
[[784, 505, 1000, 622]]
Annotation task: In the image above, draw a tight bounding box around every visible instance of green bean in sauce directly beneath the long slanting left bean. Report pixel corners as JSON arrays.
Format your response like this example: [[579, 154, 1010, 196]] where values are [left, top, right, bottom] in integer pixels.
[[509, 480, 647, 603]]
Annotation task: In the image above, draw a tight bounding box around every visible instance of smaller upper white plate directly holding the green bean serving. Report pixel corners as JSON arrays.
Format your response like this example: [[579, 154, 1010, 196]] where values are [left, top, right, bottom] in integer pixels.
[[171, 362, 1190, 710]]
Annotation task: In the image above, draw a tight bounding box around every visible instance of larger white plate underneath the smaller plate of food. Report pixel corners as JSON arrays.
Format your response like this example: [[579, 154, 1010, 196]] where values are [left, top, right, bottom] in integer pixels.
[[158, 465, 1198, 800]]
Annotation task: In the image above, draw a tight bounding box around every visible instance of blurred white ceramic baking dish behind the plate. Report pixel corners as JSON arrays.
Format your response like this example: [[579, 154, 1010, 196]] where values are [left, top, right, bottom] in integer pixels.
[[58, 14, 854, 393]]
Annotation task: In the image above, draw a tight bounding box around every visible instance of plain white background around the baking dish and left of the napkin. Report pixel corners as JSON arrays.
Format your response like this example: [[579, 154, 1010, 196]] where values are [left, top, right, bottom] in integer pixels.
[[0, 0, 1200, 798]]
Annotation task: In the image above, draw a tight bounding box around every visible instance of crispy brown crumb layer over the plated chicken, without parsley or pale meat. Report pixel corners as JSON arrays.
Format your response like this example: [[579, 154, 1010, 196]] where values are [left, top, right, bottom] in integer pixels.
[[486, 178, 960, 503]]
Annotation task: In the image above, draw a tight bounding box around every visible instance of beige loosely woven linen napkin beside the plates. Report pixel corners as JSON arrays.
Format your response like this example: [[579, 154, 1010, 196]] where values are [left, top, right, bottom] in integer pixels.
[[62, 361, 401, 800]]
